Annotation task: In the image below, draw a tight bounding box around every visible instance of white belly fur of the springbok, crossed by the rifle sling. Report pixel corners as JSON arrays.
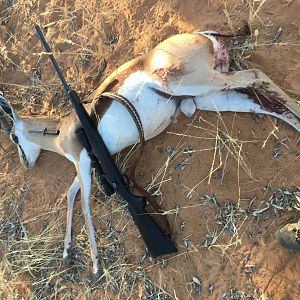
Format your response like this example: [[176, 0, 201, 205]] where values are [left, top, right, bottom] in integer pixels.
[[98, 71, 177, 154]]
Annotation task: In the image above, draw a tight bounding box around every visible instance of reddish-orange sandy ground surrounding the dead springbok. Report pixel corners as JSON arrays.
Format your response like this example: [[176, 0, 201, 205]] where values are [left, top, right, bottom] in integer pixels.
[[0, 0, 300, 299]]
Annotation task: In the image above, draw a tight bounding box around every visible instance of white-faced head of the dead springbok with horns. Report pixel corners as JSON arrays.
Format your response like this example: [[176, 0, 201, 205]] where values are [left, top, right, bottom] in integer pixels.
[[0, 92, 41, 168]]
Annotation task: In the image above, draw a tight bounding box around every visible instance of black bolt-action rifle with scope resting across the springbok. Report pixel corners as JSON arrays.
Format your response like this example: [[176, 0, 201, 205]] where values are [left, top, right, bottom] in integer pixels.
[[35, 25, 177, 257]]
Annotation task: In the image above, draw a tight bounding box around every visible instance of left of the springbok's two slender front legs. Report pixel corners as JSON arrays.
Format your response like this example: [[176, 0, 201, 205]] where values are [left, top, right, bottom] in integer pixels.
[[63, 175, 80, 259]]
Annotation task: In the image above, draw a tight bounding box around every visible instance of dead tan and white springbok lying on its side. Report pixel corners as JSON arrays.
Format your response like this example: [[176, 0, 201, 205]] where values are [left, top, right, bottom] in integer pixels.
[[0, 32, 300, 273]]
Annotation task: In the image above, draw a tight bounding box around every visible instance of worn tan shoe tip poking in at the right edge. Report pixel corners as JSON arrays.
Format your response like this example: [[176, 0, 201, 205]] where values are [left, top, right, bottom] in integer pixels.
[[276, 219, 300, 252]]
